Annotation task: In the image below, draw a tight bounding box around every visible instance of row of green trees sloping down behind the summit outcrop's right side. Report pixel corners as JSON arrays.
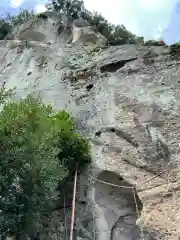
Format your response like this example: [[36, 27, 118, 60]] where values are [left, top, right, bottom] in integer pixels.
[[48, 0, 141, 44]]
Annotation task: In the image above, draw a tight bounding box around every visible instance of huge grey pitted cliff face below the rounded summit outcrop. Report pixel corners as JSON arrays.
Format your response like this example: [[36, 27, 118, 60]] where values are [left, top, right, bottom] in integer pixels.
[[0, 11, 180, 240]]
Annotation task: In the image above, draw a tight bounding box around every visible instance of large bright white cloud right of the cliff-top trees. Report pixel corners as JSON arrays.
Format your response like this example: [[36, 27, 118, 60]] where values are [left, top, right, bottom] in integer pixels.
[[84, 0, 177, 39]]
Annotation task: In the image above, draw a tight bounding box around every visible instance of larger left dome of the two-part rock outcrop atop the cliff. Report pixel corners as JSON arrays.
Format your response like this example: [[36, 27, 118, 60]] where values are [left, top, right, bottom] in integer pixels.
[[12, 12, 71, 44]]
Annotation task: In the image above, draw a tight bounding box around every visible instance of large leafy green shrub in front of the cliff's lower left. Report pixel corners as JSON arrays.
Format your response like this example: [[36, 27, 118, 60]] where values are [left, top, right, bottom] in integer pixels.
[[0, 95, 90, 239]]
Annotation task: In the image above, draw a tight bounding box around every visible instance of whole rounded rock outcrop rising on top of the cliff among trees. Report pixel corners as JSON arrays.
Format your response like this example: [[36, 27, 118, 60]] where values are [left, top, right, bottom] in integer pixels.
[[7, 12, 107, 46]]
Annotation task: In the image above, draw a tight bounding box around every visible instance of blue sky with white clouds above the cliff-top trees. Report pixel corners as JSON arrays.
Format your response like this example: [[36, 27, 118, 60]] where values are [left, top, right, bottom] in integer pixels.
[[0, 0, 180, 42]]
